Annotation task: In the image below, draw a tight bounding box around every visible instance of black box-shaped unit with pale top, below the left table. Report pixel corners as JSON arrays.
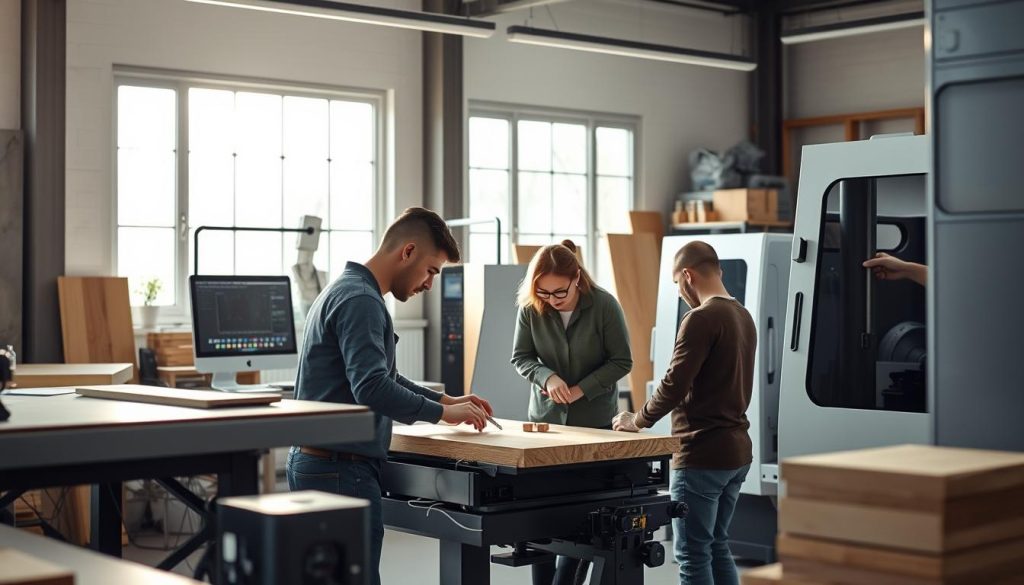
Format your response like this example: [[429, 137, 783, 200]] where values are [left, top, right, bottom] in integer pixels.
[[217, 491, 370, 585]]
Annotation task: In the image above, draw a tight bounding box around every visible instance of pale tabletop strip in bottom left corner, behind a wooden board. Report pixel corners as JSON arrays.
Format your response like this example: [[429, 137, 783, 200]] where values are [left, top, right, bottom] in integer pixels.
[[0, 525, 199, 585]]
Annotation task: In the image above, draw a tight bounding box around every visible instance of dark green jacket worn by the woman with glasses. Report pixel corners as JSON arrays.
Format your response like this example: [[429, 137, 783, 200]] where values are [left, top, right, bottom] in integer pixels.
[[511, 287, 633, 427]]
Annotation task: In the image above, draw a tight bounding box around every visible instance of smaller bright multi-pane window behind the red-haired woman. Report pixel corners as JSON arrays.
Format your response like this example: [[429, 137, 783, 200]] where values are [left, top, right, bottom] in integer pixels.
[[468, 107, 637, 288]]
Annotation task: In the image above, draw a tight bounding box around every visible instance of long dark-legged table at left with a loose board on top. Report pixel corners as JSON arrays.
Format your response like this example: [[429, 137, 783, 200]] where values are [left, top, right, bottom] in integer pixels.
[[0, 394, 373, 569]]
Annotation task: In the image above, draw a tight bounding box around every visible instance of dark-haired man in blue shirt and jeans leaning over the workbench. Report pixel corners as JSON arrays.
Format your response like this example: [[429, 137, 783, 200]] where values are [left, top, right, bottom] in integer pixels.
[[287, 207, 492, 584]]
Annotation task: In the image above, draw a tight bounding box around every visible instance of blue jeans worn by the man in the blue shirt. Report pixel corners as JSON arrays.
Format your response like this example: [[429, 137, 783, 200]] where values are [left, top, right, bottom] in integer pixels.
[[286, 447, 384, 585]]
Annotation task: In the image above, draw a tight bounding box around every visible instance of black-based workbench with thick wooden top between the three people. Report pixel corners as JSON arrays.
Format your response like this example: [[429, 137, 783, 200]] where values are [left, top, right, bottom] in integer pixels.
[[382, 419, 685, 585]]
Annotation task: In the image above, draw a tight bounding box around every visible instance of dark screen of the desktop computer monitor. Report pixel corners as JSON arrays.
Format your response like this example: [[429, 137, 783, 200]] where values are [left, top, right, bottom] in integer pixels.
[[189, 275, 296, 358]]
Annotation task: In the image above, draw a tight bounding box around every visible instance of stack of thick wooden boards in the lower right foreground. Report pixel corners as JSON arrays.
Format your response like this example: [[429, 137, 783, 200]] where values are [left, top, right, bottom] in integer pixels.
[[748, 445, 1024, 585]]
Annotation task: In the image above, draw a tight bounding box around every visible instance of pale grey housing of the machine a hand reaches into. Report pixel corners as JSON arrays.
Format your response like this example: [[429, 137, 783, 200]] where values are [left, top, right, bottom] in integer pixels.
[[778, 135, 933, 459]]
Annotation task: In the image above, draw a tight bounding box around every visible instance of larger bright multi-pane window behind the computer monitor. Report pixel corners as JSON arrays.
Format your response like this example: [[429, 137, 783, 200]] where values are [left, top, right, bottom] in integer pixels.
[[115, 77, 382, 317]]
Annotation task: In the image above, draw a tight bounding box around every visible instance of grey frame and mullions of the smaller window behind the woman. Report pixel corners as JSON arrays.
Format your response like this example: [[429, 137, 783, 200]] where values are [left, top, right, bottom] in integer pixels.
[[463, 100, 641, 278]]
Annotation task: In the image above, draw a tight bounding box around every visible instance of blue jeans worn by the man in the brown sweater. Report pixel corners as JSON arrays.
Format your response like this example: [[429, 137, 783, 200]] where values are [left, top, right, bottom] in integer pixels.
[[672, 464, 751, 585]]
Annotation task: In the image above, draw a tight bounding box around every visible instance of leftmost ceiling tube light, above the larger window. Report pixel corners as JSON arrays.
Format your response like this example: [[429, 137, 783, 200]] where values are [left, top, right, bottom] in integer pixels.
[[188, 0, 495, 39]]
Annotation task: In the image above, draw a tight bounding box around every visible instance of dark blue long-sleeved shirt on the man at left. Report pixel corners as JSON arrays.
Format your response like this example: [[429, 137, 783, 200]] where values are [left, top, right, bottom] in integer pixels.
[[295, 262, 443, 460]]
